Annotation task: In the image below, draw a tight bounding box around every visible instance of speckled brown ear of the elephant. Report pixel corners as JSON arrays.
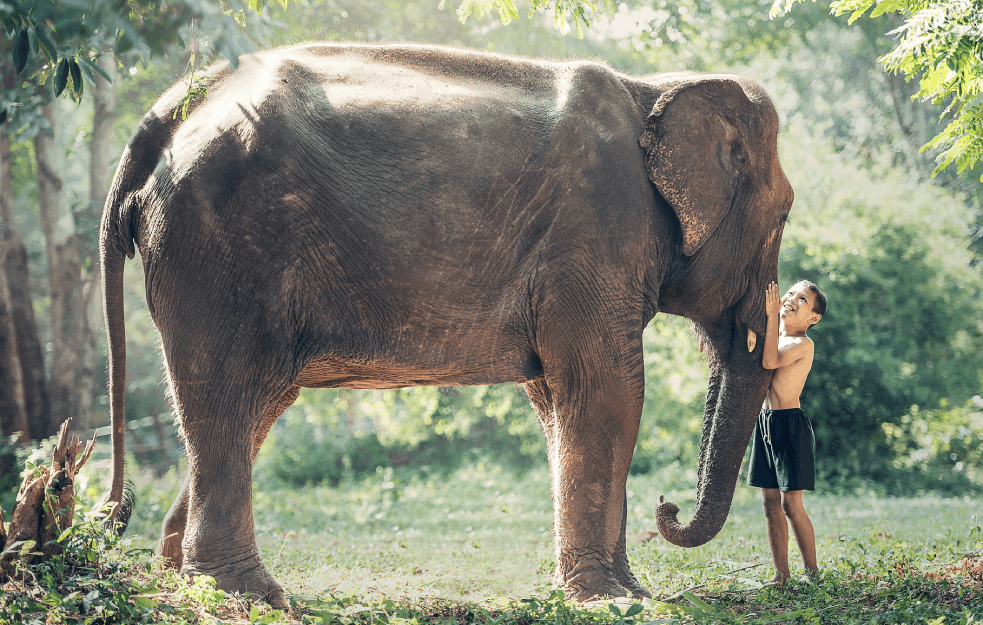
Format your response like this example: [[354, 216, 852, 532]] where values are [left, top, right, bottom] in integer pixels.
[[639, 76, 750, 256]]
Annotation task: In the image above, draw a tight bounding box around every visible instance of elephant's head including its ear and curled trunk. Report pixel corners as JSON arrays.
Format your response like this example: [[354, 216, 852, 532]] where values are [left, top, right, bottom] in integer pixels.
[[639, 74, 793, 547]]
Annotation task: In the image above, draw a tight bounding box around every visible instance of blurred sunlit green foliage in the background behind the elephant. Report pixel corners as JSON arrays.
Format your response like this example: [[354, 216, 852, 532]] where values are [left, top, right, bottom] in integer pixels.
[[3, 0, 983, 502]]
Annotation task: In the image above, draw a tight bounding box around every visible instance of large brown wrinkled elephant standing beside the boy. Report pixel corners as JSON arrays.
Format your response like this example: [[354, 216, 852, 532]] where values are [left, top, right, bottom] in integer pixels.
[[99, 43, 793, 607]]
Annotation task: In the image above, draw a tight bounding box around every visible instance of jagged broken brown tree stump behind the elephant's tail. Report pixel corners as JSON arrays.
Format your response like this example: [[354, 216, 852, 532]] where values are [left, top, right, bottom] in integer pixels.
[[0, 420, 96, 581]]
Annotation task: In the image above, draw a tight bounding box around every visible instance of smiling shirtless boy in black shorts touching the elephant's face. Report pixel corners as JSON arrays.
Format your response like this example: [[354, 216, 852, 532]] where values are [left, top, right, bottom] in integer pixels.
[[748, 280, 826, 583]]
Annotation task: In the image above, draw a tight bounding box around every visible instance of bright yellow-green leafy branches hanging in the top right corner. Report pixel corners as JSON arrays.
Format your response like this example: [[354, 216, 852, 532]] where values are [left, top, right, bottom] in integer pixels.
[[771, 0, 983, 180]]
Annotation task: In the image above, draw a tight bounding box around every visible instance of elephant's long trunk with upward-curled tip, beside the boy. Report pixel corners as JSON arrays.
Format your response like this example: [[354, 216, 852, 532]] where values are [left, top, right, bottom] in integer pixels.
[[656, 326, 771, 547]]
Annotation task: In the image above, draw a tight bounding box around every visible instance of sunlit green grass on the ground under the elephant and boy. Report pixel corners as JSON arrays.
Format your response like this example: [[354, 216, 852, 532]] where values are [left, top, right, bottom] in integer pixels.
[[7, 450, 983, 625]]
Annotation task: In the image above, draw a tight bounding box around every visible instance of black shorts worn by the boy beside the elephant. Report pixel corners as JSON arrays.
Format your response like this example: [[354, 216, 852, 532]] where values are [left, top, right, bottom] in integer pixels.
[[747, 408, 816, 491]]
